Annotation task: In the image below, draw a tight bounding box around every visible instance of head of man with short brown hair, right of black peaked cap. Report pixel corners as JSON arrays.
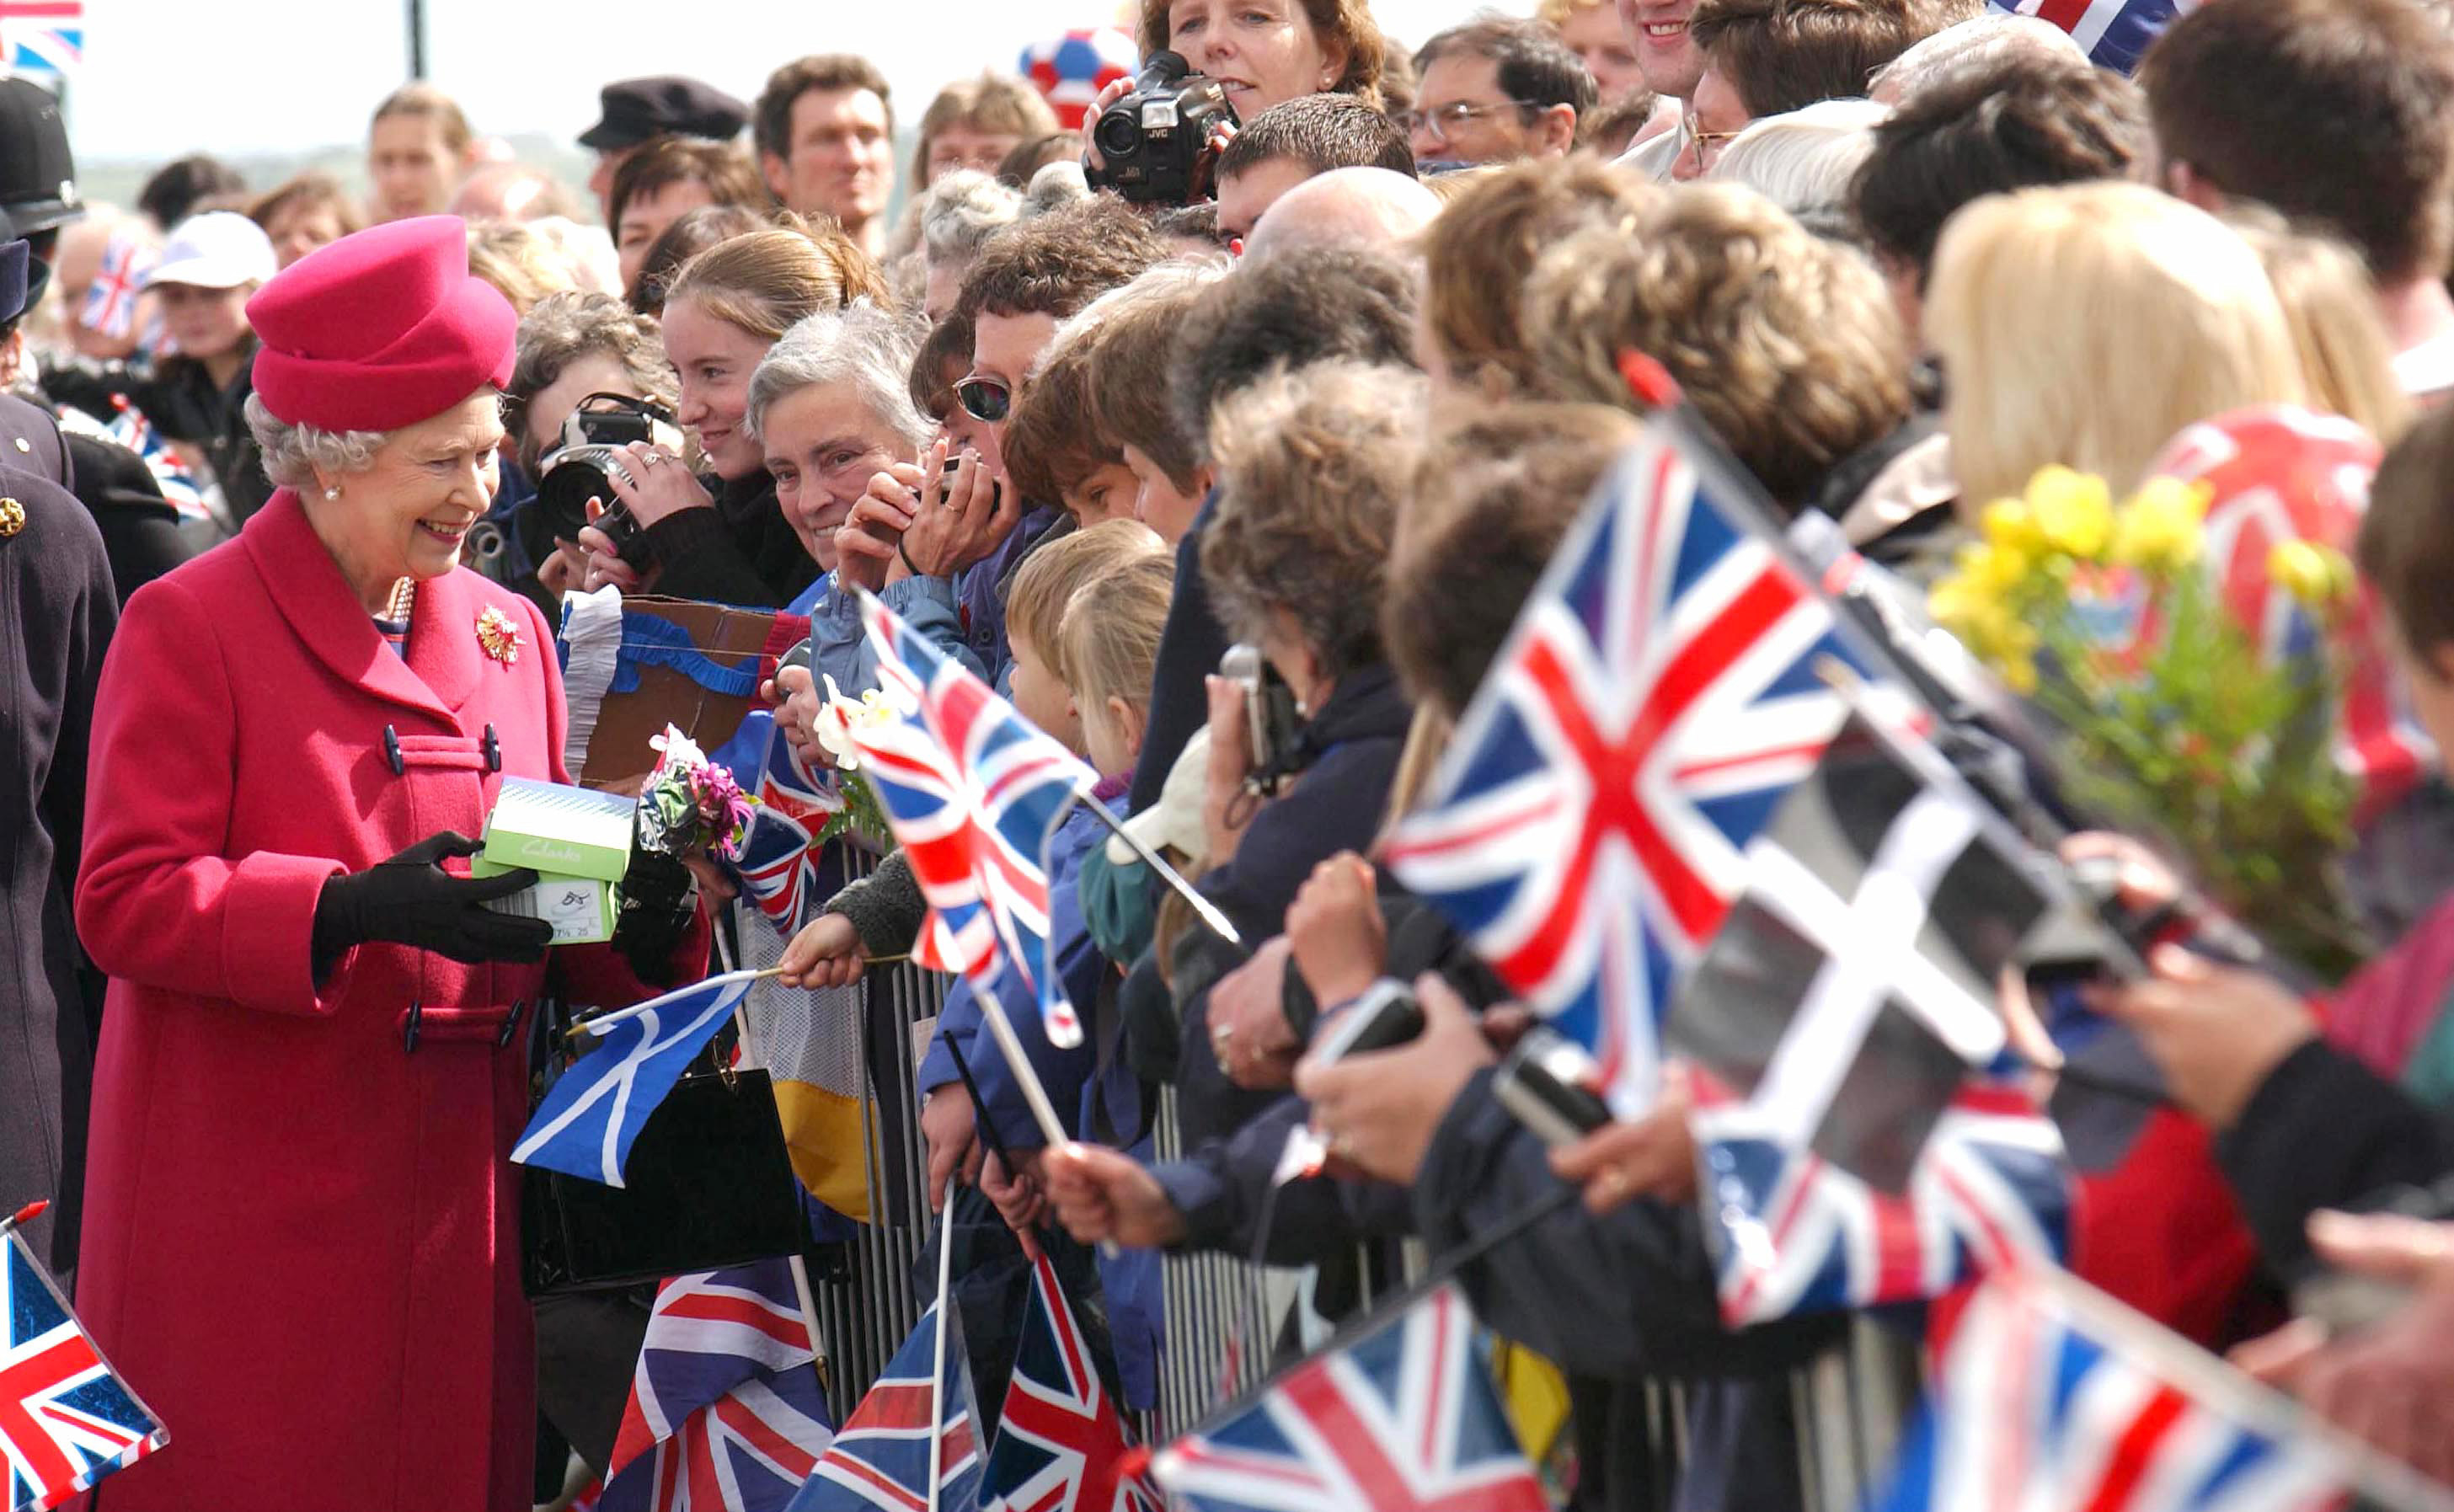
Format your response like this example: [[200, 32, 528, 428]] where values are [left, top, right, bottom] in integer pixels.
[[753, 51, 896, 258]]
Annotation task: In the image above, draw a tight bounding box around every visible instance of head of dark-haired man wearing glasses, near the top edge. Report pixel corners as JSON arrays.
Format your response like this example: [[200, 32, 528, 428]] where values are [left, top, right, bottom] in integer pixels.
[[1409, 17, 1595, 164]]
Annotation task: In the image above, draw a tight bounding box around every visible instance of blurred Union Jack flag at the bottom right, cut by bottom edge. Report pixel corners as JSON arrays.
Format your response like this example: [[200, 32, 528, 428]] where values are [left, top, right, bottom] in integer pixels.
[[1870, 1276, 2349, 1512]]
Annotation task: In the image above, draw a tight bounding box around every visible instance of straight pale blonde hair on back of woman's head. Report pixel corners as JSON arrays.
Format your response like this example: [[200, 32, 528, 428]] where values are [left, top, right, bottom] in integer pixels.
[[1927, 184, 2309, 516]]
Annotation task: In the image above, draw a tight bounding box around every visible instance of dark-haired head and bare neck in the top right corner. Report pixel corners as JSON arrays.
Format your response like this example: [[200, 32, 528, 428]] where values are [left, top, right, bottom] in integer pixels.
[[2140, 0, 2454, 400]]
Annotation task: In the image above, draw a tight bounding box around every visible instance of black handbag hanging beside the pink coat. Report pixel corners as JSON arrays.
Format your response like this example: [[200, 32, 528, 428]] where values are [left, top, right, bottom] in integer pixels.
[[521, 1070, 810, 1296]]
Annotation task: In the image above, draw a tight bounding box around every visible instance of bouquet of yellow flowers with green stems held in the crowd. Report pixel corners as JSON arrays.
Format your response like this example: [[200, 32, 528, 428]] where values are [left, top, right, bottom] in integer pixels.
[[1929, 467, 2366, 982]]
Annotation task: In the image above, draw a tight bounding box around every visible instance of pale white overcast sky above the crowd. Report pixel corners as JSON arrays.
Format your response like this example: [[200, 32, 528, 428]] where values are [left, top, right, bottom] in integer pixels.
[[69, 0, 1532, 159]]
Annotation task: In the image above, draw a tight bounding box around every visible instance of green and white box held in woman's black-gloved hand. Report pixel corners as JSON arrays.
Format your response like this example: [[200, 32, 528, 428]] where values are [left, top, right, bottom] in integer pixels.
[[468, 778, 638, 945]]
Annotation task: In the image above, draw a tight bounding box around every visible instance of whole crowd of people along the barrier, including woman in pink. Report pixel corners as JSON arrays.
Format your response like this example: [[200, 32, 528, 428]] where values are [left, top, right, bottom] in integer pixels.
[[14, 0, 2454, 1512]]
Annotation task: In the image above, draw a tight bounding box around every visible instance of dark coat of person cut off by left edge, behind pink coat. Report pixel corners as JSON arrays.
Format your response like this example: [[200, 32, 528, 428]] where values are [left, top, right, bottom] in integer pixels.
[[0, 467, 118, 1269]]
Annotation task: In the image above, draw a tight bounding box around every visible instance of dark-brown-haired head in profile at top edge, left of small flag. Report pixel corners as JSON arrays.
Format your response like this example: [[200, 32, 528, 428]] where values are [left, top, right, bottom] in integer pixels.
[[1671, 0, 1946, 179]]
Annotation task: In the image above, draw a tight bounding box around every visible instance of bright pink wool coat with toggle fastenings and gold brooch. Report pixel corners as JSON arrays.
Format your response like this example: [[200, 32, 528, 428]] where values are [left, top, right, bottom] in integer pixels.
[[76, 489, 707, 1512]]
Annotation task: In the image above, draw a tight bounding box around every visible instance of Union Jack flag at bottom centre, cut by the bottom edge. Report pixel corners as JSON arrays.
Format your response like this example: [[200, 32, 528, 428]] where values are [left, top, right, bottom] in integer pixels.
[[1151, 1286, 1551, 1512]]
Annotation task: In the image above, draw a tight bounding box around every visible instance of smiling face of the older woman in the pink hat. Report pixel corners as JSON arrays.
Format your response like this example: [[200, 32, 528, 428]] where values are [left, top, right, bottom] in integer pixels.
[[299, 387, 503, 612]]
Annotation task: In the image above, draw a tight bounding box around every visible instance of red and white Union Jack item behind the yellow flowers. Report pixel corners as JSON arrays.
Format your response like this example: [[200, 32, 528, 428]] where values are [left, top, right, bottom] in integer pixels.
[[2150, 405, 2437, 815]]
